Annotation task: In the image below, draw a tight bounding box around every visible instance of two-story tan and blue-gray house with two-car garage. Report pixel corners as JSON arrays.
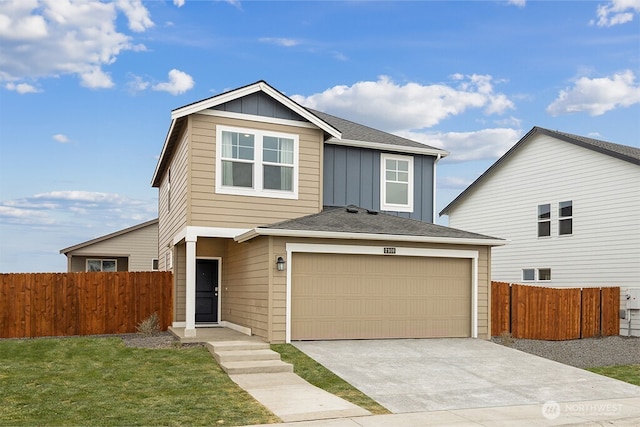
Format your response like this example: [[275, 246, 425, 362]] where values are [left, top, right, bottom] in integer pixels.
[[152, 81, 504, 342]]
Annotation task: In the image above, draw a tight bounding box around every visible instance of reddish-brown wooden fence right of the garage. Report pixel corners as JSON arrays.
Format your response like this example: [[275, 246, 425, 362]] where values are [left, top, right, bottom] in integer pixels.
[[491, 282, 620, 340]]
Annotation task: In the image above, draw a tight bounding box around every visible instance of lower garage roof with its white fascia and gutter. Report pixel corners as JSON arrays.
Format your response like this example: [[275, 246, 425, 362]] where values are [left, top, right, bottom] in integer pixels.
[[236, 206, 507, 246]]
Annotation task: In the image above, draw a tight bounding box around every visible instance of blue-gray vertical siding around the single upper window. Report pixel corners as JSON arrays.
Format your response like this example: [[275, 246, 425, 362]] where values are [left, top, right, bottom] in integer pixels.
[[323, 144, 434, 222]]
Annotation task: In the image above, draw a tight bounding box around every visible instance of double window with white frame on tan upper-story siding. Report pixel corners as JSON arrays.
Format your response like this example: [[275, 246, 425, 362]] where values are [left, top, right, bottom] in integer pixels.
[[216, 126, 298, 199]]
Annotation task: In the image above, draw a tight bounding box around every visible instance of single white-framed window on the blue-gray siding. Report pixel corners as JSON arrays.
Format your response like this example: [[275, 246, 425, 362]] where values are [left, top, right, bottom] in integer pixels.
[[380, 154, 413, 212]]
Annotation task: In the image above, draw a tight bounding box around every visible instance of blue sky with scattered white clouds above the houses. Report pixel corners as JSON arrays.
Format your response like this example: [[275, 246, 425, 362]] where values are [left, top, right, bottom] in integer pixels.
[[0, 0, 640, 272]]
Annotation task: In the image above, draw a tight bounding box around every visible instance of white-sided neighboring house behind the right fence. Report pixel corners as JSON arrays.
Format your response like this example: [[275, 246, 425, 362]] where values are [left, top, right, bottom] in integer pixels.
[[440, 127, 640, 335]]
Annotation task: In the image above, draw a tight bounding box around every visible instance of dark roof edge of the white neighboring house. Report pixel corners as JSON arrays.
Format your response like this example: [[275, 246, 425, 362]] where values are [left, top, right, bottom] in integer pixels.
[[440, 126, 640, 216]]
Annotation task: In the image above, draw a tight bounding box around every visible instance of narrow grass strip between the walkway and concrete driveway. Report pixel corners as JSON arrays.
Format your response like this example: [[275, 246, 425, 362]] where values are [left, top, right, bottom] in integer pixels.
[[271, 344, 391, 414]]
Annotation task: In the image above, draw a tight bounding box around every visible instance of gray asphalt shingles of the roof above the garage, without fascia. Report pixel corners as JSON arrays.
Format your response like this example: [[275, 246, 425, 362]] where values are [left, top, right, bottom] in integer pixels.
[[258, 206, 499, 240]]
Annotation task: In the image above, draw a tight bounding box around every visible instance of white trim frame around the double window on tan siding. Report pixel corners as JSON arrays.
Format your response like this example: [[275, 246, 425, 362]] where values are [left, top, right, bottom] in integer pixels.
[[215, 125, 300, 200]]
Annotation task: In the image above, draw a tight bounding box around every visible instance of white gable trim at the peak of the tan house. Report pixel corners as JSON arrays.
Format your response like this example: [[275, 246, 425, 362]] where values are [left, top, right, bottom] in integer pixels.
[[171, 82, 342, 138]]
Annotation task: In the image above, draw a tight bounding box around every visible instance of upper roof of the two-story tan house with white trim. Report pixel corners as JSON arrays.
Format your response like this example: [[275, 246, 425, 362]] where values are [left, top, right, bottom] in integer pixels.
[[151, 80, 449, 187]]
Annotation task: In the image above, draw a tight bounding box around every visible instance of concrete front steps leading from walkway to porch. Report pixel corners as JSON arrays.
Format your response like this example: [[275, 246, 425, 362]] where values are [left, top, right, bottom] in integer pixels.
[[207, 341, 293, 375]]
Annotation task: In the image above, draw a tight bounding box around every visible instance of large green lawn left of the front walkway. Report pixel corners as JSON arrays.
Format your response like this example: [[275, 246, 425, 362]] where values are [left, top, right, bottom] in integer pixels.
[[0, 338, 279, 426]]
